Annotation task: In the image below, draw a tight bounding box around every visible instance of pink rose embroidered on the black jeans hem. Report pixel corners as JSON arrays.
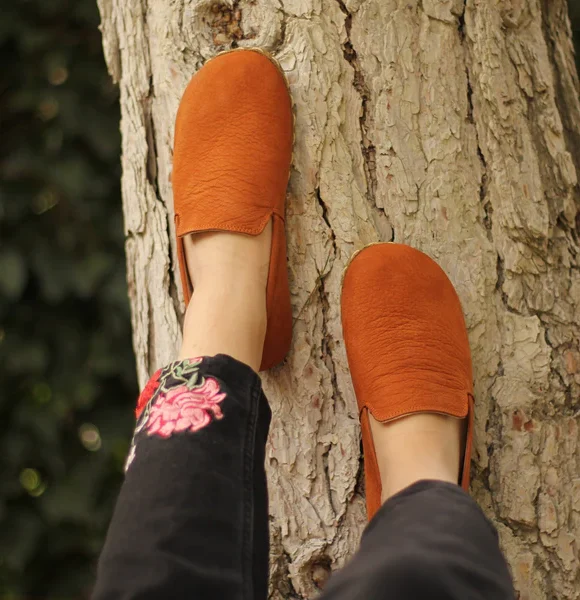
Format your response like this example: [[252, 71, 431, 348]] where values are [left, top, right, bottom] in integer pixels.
[[146, 377, 226, 437]]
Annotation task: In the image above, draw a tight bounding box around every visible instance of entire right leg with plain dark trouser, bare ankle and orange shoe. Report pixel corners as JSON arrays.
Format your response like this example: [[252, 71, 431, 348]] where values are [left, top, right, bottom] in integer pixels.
[[322, 244, 514, 600]]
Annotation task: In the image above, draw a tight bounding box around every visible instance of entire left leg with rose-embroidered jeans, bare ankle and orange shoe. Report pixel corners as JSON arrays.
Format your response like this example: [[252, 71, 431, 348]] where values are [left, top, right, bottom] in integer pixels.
[[93, 51, 292, 600]]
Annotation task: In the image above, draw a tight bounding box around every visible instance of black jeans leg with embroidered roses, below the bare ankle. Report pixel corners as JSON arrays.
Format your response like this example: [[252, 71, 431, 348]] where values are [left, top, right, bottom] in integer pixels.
[[93, 355, 270, 600]]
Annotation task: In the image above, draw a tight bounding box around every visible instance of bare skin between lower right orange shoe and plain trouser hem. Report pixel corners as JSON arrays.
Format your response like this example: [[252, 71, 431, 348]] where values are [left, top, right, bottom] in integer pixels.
[[369, 413, 465, 502]]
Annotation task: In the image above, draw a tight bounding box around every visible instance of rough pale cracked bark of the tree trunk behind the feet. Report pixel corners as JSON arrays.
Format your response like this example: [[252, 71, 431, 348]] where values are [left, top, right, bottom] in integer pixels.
[[99, 0, 580, 600]]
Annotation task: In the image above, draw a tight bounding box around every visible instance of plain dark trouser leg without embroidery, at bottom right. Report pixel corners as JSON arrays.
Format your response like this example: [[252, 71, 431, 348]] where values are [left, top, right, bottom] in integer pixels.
[[321, 480, 515, 600]]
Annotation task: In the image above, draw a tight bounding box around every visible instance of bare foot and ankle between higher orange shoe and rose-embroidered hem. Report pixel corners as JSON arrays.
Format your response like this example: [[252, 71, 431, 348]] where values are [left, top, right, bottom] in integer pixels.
[[179, 221, 272, 371]]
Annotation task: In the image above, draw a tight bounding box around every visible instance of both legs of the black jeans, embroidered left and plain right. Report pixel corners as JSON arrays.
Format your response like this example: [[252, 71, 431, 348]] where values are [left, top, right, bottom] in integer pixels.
[[93, 355, 514, 600]]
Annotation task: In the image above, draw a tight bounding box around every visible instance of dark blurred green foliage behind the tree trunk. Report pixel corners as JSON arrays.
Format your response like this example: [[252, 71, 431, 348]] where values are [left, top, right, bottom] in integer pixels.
[[0, 0, 580, 600]]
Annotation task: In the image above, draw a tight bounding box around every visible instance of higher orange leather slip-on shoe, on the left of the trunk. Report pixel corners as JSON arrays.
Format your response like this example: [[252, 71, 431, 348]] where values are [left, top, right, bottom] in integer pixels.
[[172, 49, 294, 370]]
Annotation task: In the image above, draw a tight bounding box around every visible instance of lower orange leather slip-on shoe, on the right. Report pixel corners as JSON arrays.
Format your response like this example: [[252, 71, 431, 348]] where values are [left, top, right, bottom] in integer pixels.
[[341, 244, 473, 520]]
